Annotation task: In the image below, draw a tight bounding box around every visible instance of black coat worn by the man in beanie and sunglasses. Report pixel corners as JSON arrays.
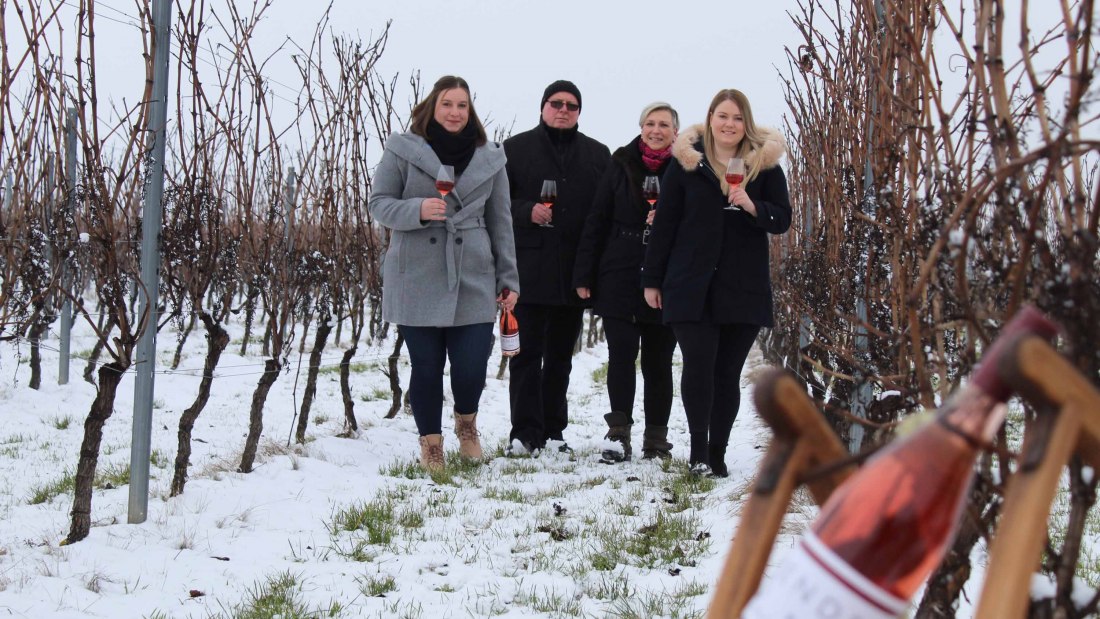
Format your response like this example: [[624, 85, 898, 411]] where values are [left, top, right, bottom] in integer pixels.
[[504, 122, 611, 307]]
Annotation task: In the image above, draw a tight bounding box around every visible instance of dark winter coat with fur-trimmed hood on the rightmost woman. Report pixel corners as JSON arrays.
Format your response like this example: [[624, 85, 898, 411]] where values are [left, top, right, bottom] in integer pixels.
[[641, 125, 791, 328]]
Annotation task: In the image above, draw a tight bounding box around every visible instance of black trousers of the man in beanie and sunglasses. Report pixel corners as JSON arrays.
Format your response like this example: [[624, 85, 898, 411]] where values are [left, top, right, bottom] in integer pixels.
[[508, 305, 584, 447]]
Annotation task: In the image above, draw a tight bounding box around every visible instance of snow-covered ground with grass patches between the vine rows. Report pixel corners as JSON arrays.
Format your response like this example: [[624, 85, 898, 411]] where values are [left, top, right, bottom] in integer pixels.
[[0, 318, 804, 618]]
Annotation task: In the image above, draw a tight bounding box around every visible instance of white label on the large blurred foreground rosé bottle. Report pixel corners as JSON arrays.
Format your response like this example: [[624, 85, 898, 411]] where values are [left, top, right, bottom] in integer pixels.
[[741, 532, 909, 619]]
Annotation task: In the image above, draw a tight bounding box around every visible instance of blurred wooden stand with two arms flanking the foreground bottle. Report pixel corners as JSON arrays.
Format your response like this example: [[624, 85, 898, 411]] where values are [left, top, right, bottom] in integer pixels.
[[707, 335, 1100, 619]]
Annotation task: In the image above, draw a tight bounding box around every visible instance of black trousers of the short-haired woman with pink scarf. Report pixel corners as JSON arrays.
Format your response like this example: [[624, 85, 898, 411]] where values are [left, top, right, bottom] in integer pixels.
[[603, 317, 677, 428]]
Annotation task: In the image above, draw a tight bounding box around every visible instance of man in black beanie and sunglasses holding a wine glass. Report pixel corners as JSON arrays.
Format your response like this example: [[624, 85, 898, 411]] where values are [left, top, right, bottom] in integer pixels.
[[504, 79, 611, 454]]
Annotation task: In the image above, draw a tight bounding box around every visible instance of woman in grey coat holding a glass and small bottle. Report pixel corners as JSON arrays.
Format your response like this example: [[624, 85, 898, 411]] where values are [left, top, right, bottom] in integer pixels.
[[370, 76, 519, 469]]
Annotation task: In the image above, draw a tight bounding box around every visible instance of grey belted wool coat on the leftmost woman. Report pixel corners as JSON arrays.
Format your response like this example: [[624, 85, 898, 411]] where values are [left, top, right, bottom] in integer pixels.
[[369, 133, 519, 327]]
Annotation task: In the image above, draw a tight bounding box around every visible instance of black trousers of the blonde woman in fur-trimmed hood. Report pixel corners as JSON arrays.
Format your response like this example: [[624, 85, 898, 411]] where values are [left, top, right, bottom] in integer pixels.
[[672, 322, 760, 467]]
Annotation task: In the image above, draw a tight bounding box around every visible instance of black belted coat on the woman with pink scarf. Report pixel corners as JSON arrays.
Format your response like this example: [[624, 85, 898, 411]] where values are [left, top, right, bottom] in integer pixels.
[[573, 136, 672, 323]]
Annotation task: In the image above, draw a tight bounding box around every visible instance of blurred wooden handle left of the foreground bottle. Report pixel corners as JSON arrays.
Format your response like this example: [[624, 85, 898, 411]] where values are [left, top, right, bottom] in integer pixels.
[[707, 369, 856, 618]]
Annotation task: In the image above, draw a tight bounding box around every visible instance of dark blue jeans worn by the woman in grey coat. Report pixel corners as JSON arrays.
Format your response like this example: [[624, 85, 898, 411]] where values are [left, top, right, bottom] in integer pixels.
[[397, 322, 493, 436]]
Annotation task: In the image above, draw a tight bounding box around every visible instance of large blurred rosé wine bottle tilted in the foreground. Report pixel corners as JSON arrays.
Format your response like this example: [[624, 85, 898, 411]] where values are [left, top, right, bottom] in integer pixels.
[[741, 307, 1057, 619]]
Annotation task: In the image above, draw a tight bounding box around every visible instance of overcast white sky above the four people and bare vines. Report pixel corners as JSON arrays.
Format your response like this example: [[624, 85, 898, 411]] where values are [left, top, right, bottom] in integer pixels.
[[23, 0, 798, 148]]
